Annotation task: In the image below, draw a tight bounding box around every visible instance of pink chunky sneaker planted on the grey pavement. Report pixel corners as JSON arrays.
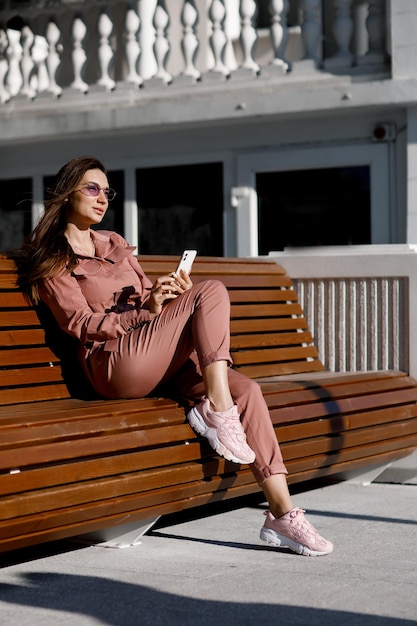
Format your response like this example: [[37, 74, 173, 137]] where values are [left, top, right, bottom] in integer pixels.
[[261, 508, 333, 556]]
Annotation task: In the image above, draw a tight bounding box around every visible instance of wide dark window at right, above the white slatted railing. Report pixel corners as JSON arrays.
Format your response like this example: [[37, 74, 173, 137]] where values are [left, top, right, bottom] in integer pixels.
[[256, 166, 371, 254]]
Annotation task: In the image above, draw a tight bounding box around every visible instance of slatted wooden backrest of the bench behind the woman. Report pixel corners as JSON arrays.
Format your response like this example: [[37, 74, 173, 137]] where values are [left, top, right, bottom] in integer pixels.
[[0, 256, 324, 405]]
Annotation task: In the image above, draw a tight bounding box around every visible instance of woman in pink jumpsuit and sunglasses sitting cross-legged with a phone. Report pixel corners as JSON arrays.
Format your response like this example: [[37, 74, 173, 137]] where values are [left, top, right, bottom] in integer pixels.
[[20, 156, 333, 556]]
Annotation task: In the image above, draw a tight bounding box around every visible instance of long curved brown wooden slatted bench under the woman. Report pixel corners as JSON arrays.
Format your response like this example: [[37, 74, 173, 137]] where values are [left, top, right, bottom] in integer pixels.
[[0, 257, 417, 551]]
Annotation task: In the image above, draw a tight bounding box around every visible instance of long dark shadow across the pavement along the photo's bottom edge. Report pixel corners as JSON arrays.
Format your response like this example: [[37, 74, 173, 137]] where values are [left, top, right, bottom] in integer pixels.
[[0, 573, 415, 626]]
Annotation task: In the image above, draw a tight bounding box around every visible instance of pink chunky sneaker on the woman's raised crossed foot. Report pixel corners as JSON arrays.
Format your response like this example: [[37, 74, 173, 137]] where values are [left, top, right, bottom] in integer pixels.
[[187, 397, 255, 463]]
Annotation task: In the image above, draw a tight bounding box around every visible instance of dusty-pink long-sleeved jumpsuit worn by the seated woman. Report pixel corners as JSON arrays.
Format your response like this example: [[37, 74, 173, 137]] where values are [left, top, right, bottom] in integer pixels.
[[41, 231, 287, 484]]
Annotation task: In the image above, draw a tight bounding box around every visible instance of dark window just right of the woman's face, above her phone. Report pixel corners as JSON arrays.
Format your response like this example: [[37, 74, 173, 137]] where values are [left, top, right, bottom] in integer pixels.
[[136, 163, 223, 256]]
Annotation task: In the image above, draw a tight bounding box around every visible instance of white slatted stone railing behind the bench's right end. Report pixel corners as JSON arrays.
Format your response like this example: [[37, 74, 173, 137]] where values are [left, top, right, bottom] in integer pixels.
[[269, 244, 417, 376]]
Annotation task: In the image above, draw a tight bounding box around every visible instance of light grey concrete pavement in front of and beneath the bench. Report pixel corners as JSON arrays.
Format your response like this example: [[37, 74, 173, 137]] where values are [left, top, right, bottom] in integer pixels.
[[0, 455, 417, 626]]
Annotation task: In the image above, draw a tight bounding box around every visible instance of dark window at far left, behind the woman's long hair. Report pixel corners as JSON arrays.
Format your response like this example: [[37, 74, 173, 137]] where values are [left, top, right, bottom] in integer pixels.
[[0, 178, 33, 252]]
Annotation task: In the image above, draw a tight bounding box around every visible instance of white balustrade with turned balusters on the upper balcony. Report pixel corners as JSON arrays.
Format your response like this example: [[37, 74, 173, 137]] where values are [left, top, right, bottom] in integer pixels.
[[0, 0, 392, 104]]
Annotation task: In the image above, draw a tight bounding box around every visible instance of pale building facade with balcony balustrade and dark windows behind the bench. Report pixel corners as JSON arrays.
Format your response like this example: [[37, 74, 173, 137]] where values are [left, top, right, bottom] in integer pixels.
[[0, 0, 417, 256]]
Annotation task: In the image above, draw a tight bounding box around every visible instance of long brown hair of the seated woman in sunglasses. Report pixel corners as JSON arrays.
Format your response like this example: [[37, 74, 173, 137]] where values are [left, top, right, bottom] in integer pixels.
[[14, 156, 107, 305]]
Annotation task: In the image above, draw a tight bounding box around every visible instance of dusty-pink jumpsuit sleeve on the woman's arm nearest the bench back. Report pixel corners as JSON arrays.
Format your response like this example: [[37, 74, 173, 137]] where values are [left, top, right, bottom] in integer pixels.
[[40, 264, 150, 345]]
